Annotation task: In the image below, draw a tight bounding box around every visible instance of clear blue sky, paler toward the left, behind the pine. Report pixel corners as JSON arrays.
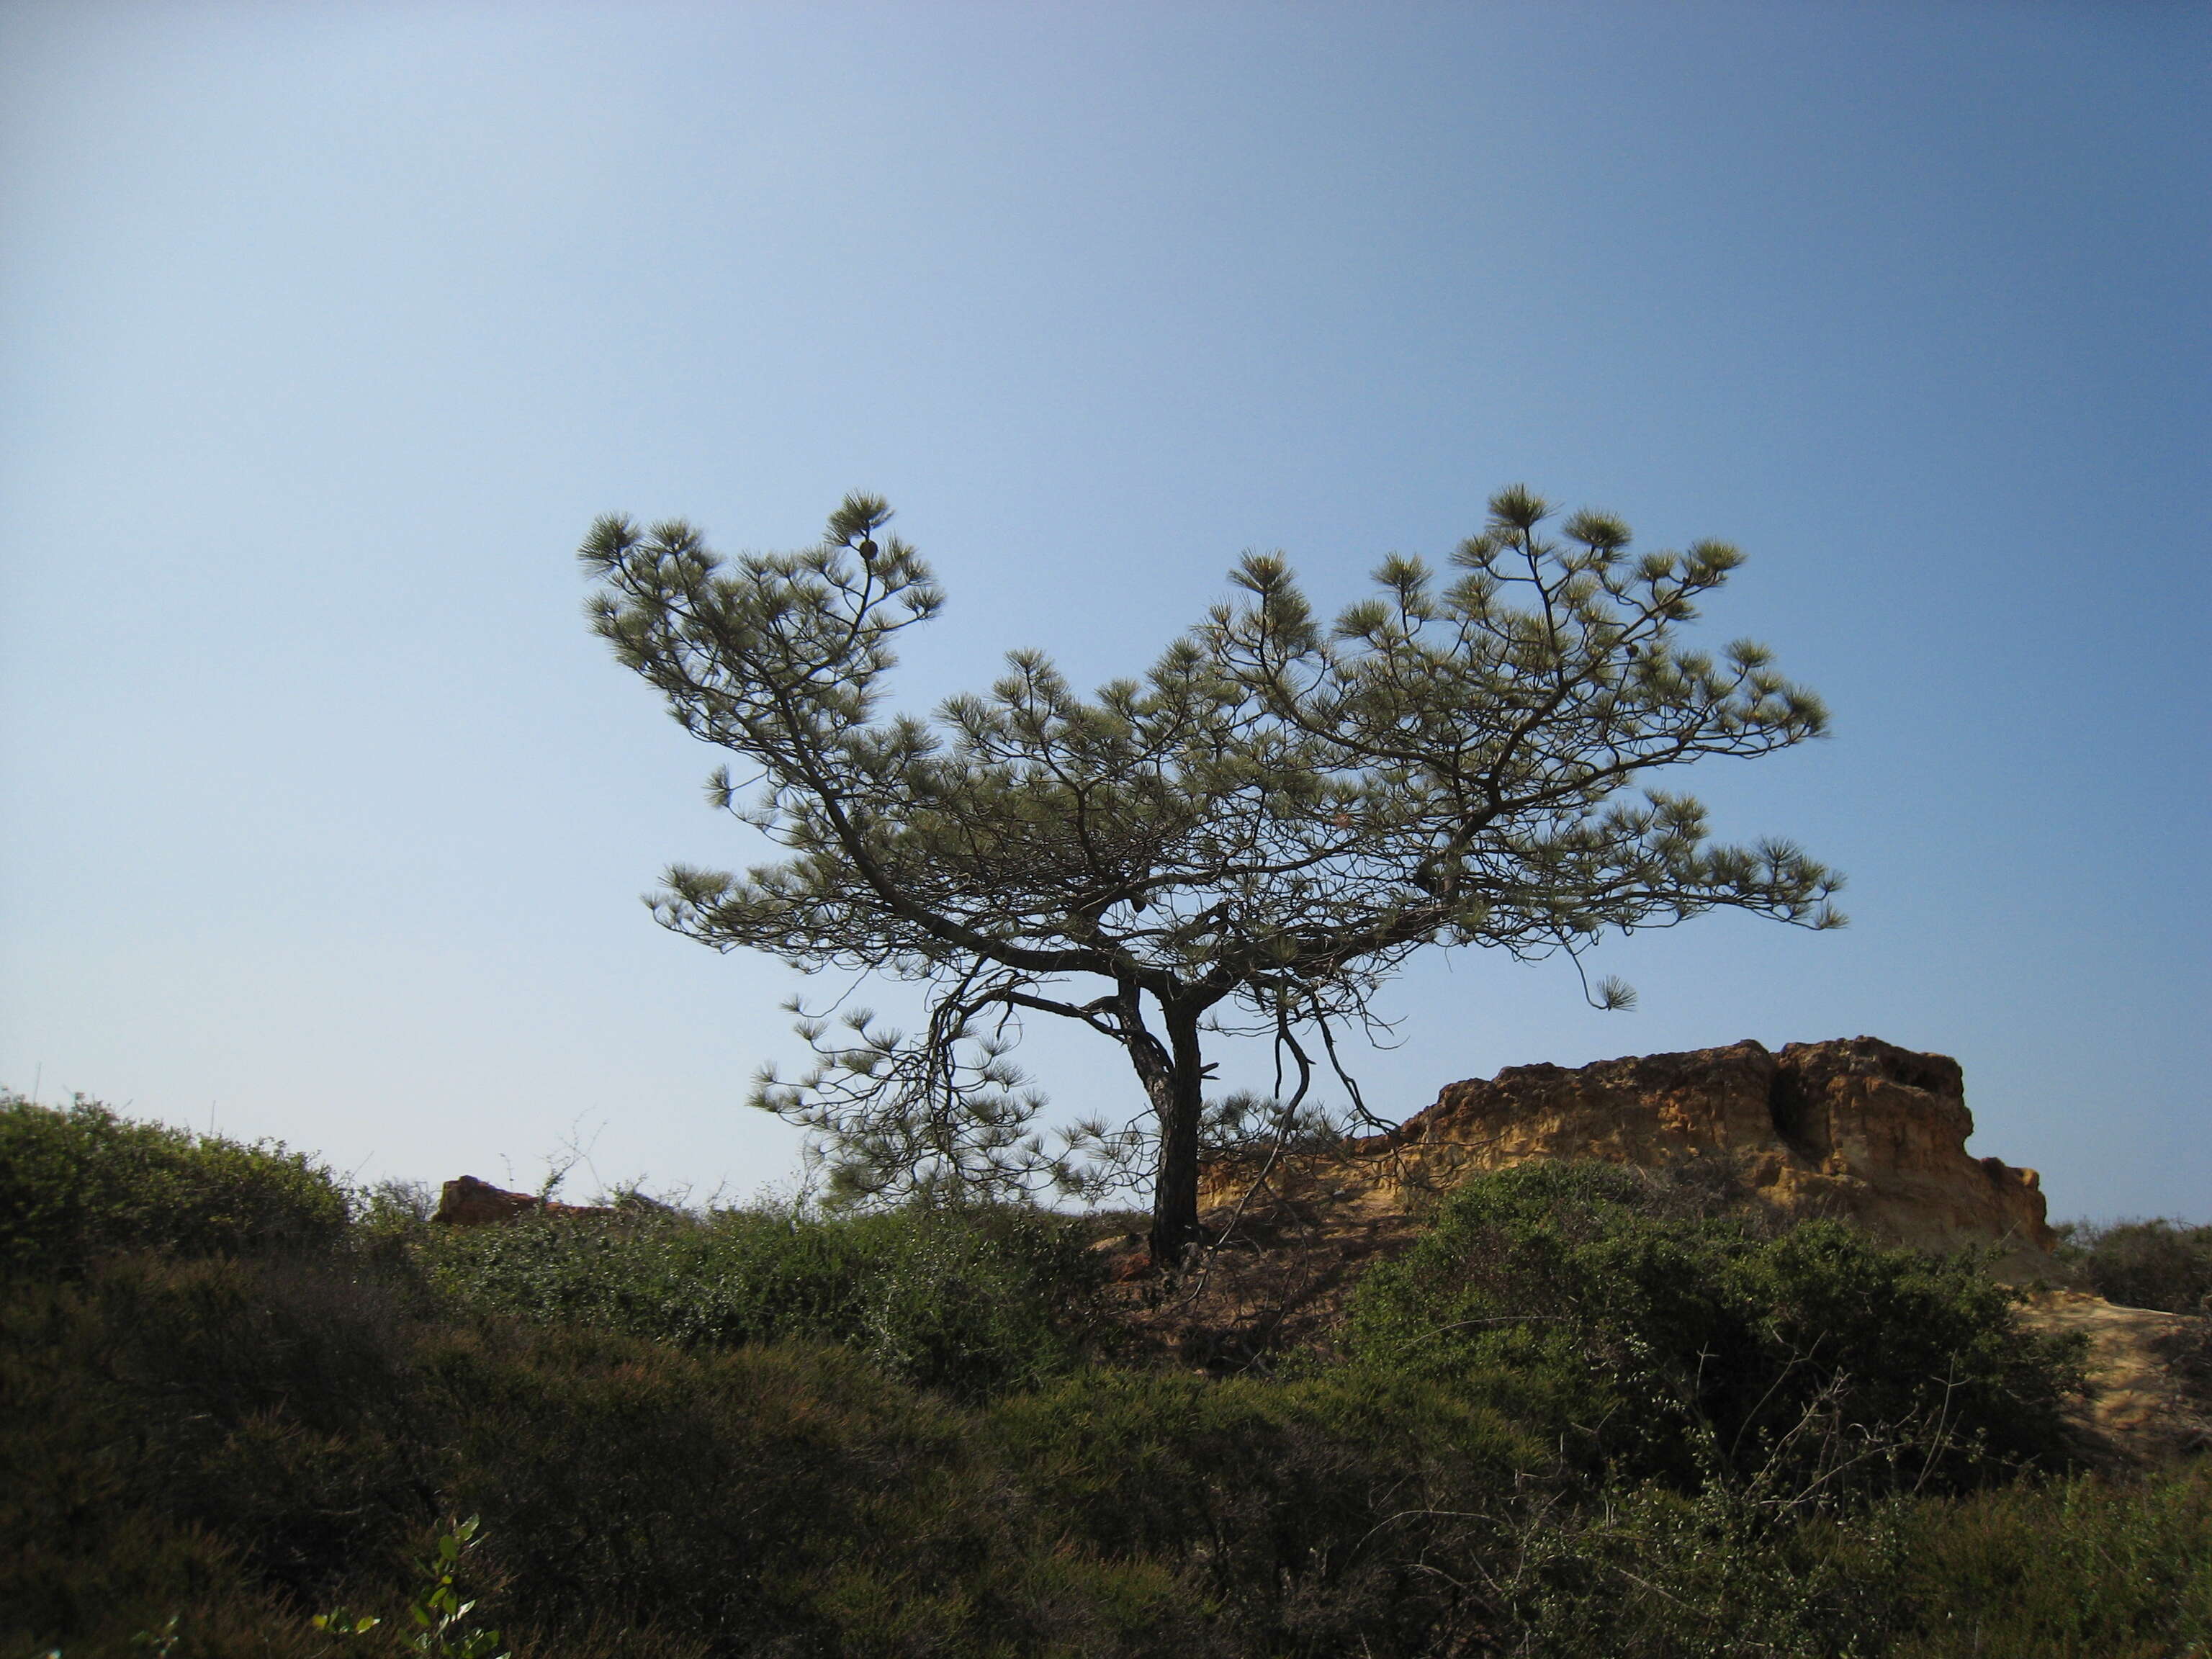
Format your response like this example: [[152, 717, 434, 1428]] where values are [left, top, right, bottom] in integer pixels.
[[0, 0, 2212, 1219]]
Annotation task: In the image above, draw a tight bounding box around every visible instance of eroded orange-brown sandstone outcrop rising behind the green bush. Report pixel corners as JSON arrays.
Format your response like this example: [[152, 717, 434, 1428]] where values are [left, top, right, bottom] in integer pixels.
[[1208, 1038, 2055, 1277]]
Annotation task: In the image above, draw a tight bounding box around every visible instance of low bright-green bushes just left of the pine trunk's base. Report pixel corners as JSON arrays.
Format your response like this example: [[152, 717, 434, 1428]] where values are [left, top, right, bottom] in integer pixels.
[[423, 1208, 1097, 1395]]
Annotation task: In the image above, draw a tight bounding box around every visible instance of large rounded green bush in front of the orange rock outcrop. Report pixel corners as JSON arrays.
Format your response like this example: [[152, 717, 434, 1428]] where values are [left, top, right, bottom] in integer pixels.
[[1347, 1164, 2072, 1496]]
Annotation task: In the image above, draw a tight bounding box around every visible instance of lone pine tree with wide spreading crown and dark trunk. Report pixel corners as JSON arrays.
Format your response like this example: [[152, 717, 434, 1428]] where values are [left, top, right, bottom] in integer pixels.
[[582, 487, 1843, 1261]]
